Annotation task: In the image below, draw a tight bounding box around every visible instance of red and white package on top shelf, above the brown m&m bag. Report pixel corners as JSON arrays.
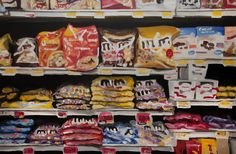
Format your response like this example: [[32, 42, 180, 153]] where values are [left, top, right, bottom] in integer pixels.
[[102, 0, 135, 9]]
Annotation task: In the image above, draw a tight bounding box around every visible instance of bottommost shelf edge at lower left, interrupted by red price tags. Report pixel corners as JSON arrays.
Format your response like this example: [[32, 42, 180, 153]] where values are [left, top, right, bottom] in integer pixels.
[[0, 144, 174, 152]]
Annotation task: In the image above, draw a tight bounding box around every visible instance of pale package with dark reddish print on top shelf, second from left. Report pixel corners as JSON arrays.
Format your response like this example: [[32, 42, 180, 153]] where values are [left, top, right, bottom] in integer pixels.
[[21, 0, 49, 10]]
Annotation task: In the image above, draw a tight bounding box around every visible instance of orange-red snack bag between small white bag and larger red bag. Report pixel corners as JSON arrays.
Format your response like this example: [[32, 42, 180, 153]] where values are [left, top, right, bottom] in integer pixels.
[[37, 29, 65, 67]]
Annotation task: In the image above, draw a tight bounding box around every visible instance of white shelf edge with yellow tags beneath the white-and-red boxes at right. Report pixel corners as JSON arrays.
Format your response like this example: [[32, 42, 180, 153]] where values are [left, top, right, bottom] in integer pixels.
[[170, 99, 236, 109]]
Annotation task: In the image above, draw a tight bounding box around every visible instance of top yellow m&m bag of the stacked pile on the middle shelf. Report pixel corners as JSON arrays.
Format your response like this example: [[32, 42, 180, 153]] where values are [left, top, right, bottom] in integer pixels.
[[91, 76, 134, 91]]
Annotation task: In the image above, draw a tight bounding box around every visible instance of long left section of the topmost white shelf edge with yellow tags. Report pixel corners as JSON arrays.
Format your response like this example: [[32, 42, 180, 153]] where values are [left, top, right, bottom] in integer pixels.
[[4, 9, 175, 19]]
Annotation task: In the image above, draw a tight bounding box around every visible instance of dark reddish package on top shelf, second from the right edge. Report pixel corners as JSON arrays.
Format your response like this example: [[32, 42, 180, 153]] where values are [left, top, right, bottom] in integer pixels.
[[201, 0, 224, 9]]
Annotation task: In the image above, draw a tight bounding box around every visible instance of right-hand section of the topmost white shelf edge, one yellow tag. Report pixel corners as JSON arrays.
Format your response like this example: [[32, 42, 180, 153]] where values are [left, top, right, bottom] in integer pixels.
[[176, 9, 236, 18]]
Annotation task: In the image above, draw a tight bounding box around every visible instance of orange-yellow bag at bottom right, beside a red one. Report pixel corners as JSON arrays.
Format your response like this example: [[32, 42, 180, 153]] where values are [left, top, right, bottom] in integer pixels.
[[198, 139, 217, 154]]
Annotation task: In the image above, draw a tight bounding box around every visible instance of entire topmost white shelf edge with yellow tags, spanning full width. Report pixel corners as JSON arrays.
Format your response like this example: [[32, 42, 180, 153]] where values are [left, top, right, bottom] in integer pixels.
[[0, 9, 236, 19]]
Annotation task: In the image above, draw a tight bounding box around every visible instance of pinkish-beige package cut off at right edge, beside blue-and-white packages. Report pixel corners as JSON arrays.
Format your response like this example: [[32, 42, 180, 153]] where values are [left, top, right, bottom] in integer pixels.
[[224, 27, 236, 57]]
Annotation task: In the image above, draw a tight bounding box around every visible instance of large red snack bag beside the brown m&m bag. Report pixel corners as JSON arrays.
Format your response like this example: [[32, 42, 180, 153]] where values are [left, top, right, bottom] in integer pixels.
[[62, 25, 99, 72]]
